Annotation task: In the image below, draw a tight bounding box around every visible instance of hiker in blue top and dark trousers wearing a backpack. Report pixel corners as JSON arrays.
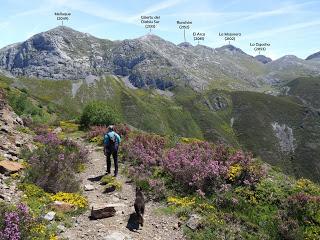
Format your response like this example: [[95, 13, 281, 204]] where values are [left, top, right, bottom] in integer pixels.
[[103, 125, 121, 177]]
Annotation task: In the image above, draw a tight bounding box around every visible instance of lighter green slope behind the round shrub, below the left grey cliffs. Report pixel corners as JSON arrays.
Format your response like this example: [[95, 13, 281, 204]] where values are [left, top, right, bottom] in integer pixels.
[[6, 77, 203, 138]]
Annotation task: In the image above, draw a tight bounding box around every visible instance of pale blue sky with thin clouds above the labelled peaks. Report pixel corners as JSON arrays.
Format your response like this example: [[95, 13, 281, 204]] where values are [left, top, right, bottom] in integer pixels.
[[0, 0, 320, 59]]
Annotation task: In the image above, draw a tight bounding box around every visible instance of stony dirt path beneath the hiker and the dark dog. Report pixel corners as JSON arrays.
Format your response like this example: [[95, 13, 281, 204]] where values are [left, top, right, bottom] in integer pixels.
[[62, 145, 185, 240]]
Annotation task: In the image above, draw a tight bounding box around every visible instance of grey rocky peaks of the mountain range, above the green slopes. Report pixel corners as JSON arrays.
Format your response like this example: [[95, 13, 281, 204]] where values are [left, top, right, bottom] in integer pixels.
[[0, 26, 320, 90]]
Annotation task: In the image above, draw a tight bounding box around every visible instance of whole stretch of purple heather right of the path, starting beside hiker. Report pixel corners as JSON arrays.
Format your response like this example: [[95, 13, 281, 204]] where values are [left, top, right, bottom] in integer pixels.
[[123, 134, 266, 196]]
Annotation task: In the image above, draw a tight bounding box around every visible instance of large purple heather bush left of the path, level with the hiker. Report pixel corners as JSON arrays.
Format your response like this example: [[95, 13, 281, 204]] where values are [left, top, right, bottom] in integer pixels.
[[24, 133, 88, 193]]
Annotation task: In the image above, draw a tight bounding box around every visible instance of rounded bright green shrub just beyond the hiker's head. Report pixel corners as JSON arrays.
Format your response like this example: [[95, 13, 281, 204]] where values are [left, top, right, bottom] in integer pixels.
[[80, 102, 120, 128]]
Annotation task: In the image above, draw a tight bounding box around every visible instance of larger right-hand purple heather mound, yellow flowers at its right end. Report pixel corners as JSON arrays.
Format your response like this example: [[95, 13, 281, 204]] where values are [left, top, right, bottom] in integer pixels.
[[163, 142, 265, 192]]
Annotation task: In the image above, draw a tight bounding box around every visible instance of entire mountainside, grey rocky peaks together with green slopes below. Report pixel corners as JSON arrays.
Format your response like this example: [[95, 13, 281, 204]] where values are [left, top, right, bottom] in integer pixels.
[[0, 27, 320, 182]]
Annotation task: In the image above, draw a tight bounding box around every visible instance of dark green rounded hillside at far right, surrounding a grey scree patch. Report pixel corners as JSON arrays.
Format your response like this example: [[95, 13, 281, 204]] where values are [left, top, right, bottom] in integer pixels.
[[232, 92, 320, 181]]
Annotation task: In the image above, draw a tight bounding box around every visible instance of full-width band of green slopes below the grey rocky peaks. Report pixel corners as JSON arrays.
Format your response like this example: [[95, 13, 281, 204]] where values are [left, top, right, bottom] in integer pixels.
[[1, 74, 320, 181]]
